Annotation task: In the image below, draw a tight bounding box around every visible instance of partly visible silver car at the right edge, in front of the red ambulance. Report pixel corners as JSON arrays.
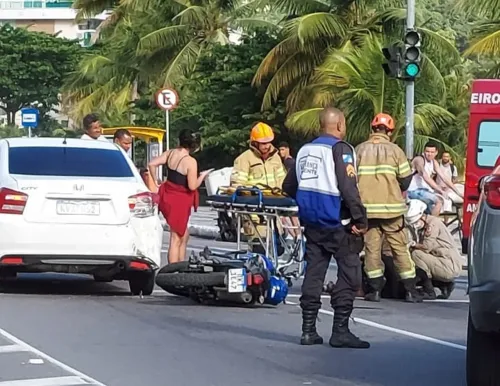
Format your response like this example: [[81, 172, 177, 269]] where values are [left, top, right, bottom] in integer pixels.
[[467, 157, 500, 386]]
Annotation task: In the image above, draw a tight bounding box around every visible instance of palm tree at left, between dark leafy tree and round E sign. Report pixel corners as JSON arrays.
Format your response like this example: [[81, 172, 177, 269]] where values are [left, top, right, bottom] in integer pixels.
[[63, 4, 177, 121]]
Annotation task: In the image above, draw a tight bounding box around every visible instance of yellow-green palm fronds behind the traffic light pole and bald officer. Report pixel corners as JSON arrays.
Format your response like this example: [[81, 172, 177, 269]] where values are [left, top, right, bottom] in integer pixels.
[[287, 34, 455, 150]]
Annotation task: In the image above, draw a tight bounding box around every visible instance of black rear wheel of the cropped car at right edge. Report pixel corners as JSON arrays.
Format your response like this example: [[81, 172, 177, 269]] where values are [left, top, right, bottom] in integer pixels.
[[466, 312, 500, 386]]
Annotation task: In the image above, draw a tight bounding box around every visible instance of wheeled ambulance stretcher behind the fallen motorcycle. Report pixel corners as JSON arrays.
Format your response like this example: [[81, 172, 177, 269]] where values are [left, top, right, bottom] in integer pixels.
[[207, 188, 305, 281]]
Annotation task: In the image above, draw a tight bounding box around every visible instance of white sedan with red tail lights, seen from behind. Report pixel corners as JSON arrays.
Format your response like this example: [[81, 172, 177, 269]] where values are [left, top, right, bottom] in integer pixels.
[[0, 138, 163, 295]]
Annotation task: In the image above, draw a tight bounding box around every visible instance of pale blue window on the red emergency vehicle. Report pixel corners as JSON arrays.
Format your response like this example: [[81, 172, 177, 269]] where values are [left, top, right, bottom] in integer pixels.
[[477, 121, 500, 168]]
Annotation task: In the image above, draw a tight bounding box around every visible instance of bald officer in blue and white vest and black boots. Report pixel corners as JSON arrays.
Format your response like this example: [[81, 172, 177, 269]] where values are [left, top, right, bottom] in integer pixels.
[[283, 108, 370, 348]]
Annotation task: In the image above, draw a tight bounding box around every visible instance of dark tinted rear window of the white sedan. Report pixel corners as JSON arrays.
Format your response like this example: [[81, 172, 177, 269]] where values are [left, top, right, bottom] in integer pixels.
[[9, 147, 134, 177]]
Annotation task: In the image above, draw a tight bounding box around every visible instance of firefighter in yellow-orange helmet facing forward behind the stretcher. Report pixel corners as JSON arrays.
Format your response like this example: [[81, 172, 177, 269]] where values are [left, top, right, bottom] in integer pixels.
[[231, 122, 286, 254]]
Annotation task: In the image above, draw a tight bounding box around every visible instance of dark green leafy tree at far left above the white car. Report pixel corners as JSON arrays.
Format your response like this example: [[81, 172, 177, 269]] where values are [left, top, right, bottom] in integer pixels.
[[0, 24, 81, 124]]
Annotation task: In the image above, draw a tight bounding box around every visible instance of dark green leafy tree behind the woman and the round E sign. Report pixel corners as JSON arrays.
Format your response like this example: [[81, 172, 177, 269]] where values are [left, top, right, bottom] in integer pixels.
[[133, 33, 293, 167]]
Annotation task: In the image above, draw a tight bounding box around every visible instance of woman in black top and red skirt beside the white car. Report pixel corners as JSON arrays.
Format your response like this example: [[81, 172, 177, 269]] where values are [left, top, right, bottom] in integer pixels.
[[148, 129, 211, 264]]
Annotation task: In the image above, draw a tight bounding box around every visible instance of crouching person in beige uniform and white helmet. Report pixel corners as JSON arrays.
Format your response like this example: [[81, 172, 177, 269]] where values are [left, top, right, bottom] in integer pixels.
[[406, 200, 463, 300]]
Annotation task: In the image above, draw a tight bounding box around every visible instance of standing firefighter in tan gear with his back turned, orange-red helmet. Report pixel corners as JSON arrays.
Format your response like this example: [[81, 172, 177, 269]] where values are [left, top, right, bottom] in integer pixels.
[[356, 113, 422, 303]]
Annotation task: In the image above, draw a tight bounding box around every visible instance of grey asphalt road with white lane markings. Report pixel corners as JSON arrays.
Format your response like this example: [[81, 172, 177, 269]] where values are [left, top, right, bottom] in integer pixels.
[[0, 232, 467, 386]]
